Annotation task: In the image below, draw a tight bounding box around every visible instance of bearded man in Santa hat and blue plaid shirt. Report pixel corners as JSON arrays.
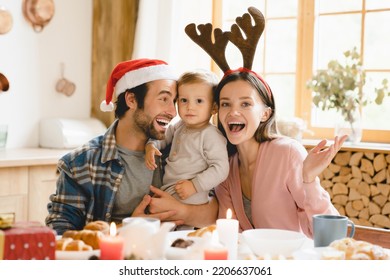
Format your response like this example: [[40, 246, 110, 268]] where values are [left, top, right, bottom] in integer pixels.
[[46, 59, 218, 234]]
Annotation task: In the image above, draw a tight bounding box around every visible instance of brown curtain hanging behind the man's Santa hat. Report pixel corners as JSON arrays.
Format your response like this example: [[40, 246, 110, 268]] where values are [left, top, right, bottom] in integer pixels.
[[91, 0, 139, 126]]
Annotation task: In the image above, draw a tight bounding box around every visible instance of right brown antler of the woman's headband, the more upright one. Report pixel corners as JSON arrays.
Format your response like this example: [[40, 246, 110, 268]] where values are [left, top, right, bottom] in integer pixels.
[[226, 7, 265, 70]]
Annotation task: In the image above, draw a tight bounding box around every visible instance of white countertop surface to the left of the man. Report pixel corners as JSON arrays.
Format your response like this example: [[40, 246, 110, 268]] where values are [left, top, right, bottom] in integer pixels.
[[0, 148, 70, 168]]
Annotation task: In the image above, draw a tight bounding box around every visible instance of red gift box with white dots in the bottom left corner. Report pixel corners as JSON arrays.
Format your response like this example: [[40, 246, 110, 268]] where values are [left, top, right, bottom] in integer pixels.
[[0, 222, 56, 260]]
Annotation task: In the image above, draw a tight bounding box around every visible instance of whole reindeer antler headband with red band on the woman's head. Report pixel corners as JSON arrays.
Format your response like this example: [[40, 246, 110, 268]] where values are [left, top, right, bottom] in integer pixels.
[[185, 7, 272, 96]]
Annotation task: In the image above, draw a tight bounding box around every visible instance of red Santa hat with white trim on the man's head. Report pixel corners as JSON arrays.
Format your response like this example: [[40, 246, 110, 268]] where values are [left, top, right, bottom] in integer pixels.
[[100, 58, 177, 112]]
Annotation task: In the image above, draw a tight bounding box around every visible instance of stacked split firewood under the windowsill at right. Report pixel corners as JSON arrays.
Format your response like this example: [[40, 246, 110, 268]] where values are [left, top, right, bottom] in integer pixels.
[[320, 151, 390, 229]]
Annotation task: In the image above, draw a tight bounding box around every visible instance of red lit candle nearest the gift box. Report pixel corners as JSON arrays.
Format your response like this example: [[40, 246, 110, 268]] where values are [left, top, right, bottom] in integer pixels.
[[99, 222, 124, 260]]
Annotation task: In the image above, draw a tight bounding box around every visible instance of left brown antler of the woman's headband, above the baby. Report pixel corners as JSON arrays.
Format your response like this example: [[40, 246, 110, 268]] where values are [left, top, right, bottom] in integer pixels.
[[185, 23, 230, 72]]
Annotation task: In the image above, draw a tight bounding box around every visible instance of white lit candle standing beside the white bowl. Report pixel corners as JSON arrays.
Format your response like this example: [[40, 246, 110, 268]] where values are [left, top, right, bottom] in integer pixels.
[[217, 208, 238, 260]]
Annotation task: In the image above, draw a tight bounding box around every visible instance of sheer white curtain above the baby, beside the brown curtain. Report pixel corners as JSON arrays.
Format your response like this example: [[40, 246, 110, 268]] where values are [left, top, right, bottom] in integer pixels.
[[132, 0, 213, 73]]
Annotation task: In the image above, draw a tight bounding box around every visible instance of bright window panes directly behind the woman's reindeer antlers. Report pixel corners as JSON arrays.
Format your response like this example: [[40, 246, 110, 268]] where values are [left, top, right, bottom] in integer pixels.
[[222, 0, 298, 122]]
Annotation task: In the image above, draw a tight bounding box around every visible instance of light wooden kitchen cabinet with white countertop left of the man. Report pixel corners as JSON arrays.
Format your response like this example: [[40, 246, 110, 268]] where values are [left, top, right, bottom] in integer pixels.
[[0, 148, 68, 224]]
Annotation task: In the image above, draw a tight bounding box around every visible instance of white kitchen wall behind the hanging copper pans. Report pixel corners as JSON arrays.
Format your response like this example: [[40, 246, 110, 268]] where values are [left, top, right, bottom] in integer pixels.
[[0, 0, 92, 148]]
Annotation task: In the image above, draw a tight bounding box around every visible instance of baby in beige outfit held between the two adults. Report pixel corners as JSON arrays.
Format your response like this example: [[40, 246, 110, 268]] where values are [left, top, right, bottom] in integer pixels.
[[145, 71, 229, 217]]
